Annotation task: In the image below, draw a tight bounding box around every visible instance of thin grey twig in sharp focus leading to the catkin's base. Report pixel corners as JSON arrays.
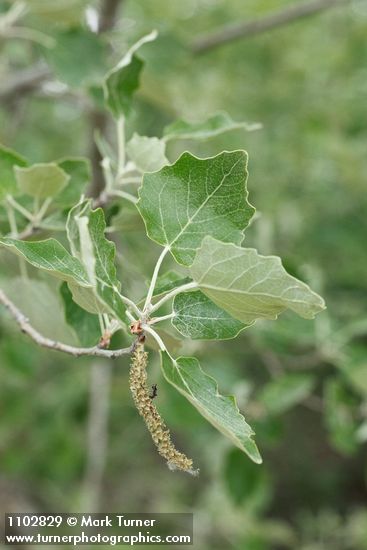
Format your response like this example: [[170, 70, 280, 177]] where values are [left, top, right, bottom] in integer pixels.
[[0, 289, 135, 359]]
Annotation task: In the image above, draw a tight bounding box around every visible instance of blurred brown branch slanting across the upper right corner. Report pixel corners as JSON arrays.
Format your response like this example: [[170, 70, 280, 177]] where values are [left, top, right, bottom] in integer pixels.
[[192, 0, 351, 54]]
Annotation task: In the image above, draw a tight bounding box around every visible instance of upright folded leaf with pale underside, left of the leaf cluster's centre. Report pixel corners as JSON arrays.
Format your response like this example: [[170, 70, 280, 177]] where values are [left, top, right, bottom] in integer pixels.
[[66, 200, 126, 322]]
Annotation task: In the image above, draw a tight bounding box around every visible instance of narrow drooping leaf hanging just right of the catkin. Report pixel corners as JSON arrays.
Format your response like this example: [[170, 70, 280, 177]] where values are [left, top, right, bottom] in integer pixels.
[[161, 352, 262, 464]]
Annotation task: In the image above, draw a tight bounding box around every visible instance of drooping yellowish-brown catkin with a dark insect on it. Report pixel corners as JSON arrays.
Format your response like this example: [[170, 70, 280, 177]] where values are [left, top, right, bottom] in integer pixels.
[[130, 344, 198, 475]]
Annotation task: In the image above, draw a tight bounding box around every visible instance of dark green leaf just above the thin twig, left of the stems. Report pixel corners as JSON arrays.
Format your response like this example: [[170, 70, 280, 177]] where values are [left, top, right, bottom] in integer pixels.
[[60, 283, 101, 346]]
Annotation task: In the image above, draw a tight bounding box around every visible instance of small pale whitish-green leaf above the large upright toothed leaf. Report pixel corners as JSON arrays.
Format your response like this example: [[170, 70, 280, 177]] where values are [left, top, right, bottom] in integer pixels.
[[126, 133, 168, 172]]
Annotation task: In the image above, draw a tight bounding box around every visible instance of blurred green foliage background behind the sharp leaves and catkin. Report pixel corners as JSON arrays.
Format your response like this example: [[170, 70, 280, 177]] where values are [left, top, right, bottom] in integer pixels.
[[0, 0, 367, 550]]
